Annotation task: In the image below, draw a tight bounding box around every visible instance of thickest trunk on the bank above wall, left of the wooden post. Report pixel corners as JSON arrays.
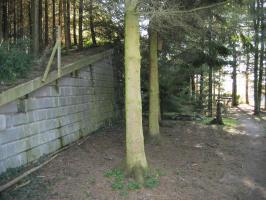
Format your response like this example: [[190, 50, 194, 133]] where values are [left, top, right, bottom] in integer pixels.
[[32, 0, 40, 58]]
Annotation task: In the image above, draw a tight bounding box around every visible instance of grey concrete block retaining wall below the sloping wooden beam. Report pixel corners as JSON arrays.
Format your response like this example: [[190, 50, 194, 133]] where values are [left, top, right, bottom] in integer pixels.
[[0, 57, 116, 174]]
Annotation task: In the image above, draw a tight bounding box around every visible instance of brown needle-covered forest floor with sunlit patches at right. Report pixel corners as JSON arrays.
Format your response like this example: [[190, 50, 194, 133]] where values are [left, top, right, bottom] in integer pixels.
[[0, 106, 266, 200]]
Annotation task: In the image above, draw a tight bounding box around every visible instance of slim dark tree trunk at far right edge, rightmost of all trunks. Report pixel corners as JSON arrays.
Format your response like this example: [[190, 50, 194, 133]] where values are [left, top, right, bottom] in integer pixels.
[[258, 0, 265, 111]]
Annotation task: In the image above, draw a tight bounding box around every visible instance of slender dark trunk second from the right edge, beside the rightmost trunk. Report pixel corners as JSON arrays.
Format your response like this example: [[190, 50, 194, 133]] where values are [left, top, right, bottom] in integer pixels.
[[253, 3, 260, 115]]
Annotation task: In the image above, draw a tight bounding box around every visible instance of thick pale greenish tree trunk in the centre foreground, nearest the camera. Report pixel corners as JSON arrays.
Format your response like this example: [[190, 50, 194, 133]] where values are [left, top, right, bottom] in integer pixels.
[[125, 0, 148, 183]]
